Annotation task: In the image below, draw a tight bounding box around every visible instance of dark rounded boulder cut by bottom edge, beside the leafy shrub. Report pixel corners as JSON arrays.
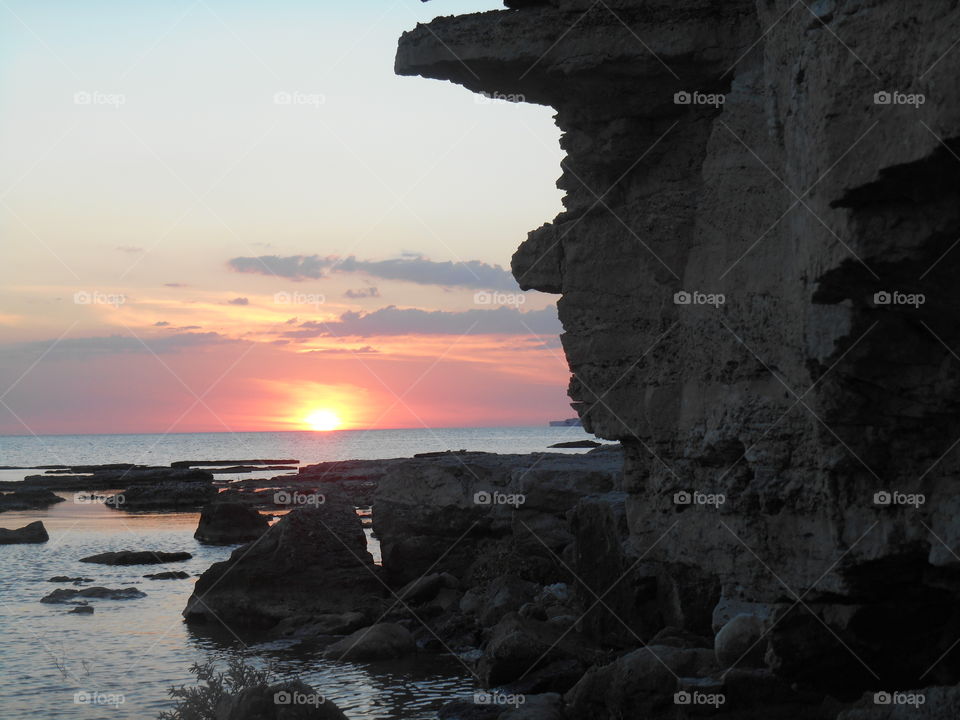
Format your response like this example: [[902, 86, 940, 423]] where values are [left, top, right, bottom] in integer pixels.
[[214, 680, 347, 720]]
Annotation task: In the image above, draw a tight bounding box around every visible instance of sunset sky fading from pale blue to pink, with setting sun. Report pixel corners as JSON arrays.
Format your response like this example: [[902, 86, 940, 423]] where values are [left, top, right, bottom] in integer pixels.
[[0, 0, 571, 435]]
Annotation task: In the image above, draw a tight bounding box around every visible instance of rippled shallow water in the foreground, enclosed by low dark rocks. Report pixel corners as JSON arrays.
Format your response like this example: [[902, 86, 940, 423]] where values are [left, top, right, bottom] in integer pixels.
[[0, 493, 474, 720]]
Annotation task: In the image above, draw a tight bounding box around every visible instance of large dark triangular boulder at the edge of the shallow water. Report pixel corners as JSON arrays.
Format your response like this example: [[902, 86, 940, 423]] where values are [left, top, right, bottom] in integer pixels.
[[183, 502, 385, 632]]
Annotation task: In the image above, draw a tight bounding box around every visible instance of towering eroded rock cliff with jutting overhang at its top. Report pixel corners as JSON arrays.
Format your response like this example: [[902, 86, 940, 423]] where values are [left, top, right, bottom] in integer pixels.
[[397, 0, 960, 717]]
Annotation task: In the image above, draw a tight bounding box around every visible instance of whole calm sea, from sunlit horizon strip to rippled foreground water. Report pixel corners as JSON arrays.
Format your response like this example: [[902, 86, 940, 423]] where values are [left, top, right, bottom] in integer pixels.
[[0, 427, 590, 720]]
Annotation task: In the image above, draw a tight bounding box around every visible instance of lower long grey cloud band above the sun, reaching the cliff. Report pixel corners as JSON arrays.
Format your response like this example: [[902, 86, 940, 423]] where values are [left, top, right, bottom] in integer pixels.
[[283, 305, 563, 339]]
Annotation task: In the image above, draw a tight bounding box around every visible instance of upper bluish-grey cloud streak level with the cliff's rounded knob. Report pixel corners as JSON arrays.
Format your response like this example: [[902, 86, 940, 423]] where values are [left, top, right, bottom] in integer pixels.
[[229, 254, 517, 290]]
